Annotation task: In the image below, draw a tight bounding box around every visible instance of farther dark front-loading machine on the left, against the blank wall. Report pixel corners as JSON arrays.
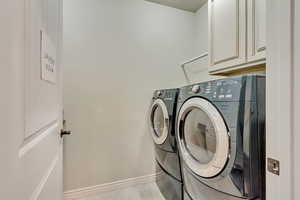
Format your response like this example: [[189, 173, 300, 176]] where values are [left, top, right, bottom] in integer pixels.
[[148, 89, 183, 200]]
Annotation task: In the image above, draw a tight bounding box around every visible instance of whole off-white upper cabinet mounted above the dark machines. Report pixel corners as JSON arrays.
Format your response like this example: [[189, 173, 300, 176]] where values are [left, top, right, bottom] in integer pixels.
[[209, 0, 266, 74]]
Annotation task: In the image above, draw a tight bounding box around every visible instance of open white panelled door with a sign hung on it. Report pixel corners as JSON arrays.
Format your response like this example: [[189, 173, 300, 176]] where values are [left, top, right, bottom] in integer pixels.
[[0, 0, 63, 200]]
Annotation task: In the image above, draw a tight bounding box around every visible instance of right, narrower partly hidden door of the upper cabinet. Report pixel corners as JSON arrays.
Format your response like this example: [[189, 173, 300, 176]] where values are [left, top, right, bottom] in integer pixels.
[[247, 0, 266, 62]]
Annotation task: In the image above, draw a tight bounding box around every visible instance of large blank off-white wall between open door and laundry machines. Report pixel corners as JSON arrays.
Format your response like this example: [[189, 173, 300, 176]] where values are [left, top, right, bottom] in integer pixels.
[[64, 0, 199, 190]]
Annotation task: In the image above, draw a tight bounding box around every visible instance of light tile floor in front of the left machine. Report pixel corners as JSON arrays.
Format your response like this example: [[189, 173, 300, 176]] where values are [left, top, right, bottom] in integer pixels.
[[81, 183, 164, 200]]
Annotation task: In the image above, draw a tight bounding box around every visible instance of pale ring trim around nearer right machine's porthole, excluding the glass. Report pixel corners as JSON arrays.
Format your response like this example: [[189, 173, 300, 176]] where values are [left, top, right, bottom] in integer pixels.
[[176, 97, 230, 178]]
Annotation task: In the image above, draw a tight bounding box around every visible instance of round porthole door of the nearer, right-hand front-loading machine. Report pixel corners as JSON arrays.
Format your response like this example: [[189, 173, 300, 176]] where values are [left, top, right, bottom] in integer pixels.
[[177, 97, 230, 178]]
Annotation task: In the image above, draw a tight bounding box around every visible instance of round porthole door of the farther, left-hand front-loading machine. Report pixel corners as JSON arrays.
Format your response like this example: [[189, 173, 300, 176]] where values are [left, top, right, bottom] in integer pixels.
[[149, 99, 170, 145]]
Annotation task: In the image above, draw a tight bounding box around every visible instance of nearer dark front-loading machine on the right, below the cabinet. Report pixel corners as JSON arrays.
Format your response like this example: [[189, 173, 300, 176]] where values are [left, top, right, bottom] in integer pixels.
[[176, 75, 265, 200]]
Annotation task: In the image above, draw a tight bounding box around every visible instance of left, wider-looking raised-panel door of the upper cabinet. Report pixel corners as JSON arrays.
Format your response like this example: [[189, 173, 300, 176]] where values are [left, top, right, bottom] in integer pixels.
[[209, 0, 247, 73]]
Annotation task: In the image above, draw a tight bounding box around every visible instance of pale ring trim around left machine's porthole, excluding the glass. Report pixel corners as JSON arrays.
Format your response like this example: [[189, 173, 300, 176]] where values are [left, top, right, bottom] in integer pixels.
[[148, 99, 170, 145]]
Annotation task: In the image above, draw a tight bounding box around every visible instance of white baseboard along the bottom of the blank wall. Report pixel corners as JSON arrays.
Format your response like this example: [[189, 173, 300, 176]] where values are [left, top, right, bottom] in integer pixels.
[[64, 173, 161, 200]]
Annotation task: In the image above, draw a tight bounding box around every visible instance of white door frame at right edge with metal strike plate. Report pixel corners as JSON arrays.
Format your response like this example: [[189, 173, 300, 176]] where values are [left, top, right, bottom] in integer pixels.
[[266, 0, 300, 200]]
